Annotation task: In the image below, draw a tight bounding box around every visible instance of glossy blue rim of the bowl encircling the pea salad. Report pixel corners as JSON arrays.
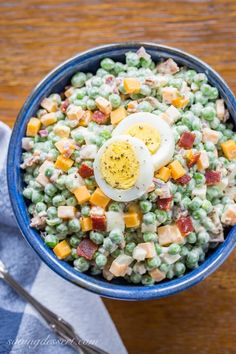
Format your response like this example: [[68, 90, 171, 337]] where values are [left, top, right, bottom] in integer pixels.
[[7, 41, 236, 300]]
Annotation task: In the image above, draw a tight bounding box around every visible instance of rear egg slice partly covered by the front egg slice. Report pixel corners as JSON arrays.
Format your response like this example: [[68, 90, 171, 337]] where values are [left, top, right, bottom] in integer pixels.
[[112, 112, 175, 171]]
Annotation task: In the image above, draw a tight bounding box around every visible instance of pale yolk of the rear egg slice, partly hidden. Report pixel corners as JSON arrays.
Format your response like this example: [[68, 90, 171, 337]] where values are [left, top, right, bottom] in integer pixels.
[[124, 123, 161, 154]]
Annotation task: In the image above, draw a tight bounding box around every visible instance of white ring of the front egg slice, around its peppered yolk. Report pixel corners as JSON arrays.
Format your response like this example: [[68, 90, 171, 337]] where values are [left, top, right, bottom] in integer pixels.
[[93, 135, 154, 202]]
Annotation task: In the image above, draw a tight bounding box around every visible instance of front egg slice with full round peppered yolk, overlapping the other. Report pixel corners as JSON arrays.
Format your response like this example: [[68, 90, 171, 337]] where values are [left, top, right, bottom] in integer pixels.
[[94, 134, 154, 202]]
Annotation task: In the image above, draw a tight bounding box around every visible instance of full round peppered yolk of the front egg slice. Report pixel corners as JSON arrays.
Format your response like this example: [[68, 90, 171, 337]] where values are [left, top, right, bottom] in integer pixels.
[[100, 141, 139, 189]]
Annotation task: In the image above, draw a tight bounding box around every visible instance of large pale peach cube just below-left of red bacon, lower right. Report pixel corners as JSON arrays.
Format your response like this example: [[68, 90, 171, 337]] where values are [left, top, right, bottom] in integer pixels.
[[157, 224, 184, 246]]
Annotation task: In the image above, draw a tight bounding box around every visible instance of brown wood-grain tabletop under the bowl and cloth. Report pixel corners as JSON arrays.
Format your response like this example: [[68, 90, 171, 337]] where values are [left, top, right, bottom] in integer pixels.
[[0, 0, 236, 354]]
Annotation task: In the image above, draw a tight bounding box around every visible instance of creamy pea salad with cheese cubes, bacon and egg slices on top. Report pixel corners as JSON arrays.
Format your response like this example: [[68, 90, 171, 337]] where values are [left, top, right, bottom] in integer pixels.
[[21, 47, 236, 285]]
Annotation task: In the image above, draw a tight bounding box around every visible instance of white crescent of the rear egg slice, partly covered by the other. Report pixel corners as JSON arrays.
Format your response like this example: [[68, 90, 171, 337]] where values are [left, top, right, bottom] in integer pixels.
[[112, 112, 175, 171]]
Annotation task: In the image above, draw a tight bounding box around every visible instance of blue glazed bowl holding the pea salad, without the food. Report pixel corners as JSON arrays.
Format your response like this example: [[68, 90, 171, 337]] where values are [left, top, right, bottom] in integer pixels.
[[7, 43, 236, 300]]
